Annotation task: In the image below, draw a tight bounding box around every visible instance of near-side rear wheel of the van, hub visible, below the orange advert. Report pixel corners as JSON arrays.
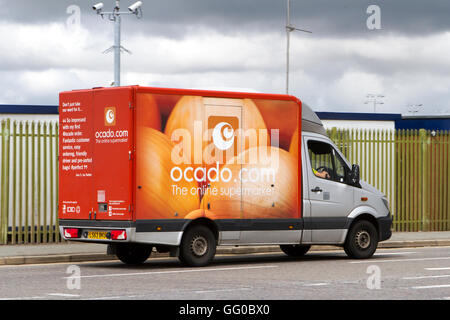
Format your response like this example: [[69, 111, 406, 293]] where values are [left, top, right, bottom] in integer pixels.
[[178, 225, 217, 267]]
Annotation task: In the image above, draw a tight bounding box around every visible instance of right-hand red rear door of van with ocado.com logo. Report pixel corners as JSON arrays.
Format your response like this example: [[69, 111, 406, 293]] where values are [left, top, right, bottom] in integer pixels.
[[90, 87, 133, 220]]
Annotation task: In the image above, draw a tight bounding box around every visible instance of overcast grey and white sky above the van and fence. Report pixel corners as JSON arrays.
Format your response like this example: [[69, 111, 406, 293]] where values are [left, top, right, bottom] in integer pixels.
[[0, 0, 450, 114]]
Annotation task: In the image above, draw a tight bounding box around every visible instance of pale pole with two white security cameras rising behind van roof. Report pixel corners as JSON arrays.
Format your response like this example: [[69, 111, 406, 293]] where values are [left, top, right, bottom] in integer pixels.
[[92, 0, 142, 87]]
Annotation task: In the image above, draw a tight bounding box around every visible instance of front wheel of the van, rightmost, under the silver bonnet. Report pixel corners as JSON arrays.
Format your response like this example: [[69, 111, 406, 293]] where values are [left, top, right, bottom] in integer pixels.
[[344, 220, 378, 259]]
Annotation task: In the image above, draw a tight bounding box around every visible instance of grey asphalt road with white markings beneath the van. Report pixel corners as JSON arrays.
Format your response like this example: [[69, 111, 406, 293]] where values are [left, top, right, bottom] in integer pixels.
[[0, 247, 450, 300]]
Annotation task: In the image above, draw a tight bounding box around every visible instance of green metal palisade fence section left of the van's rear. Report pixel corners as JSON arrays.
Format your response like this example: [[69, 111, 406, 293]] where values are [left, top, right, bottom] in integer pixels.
[[0, 119, 61, 244]]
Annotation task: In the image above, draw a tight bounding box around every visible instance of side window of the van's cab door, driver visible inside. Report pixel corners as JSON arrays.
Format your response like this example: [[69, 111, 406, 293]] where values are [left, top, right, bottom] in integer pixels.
[[308, 140, 349, 183]]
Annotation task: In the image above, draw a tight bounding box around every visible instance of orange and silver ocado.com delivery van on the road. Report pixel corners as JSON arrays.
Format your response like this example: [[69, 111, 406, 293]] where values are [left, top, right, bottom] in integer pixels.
[[59, 86, 392, 266]]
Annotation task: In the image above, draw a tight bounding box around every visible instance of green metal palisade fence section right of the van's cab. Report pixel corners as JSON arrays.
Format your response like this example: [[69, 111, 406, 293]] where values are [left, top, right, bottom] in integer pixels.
[[328, 128, 450, 231]]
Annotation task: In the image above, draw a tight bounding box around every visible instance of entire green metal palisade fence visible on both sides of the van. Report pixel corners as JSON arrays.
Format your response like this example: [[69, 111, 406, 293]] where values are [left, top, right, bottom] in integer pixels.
[[0, 120, 450, 244]]
